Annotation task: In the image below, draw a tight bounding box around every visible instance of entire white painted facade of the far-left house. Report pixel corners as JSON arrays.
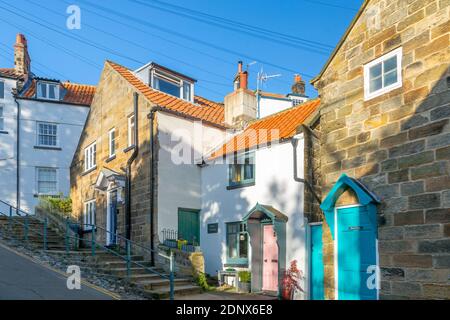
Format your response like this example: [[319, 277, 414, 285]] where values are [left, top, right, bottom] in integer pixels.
[[0, 79, 89, 214]]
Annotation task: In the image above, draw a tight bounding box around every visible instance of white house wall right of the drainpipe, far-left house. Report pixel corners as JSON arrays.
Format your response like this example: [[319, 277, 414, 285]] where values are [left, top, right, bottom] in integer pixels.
[[18, 99, 89, 213]]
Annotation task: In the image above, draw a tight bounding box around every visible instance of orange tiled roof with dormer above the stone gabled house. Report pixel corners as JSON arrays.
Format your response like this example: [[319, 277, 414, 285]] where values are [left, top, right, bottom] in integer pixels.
[[106, 61, 225, 126]]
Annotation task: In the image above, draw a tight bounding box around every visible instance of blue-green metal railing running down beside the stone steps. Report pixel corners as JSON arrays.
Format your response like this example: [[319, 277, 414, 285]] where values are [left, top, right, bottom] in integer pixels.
[[0, 200, 175, 300]]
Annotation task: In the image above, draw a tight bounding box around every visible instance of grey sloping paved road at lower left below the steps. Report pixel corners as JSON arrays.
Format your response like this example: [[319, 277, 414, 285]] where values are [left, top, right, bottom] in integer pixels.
[[0, 245, 113, 300]]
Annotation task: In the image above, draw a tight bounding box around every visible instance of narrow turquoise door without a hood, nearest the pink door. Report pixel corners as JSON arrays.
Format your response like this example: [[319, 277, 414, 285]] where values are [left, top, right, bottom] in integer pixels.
[[310, 224, 324, 300]]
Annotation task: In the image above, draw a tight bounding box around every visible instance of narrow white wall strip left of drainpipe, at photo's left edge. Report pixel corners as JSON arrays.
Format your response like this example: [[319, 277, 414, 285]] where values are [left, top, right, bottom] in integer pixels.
[[0, 78, 17, 212]]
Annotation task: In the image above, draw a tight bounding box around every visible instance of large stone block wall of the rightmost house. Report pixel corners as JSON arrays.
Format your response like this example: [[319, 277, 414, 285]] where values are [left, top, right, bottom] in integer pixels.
[[315, 0, 450, 299]]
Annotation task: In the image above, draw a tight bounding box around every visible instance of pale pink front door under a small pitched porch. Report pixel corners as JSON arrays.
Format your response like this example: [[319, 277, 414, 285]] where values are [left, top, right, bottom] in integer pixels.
[[262, 225, 278, 291]]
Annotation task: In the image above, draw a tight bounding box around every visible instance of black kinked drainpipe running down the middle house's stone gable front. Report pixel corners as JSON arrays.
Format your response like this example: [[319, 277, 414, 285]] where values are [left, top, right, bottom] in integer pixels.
[[125, 92, 139, 240]]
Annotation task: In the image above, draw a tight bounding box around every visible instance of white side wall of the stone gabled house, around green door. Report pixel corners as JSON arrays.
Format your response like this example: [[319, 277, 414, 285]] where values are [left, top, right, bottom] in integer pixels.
[[157, 112, 226, 239]]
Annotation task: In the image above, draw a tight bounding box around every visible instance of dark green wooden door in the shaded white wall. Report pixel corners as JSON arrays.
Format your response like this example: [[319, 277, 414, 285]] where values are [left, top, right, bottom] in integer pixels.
[[178, 208, 200, 245]]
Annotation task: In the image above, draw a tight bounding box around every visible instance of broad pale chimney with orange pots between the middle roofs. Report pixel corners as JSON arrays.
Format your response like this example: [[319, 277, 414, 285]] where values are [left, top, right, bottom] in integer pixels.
[[225, 61, 256, 128]]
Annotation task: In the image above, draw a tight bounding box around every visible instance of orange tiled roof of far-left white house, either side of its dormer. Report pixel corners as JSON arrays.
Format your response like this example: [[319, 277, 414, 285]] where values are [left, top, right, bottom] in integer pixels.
[[21, 79, 95, 106]]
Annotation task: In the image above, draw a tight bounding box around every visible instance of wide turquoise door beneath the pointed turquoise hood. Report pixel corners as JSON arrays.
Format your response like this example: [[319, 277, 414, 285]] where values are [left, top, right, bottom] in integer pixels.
[[337, 206, 377, 300]]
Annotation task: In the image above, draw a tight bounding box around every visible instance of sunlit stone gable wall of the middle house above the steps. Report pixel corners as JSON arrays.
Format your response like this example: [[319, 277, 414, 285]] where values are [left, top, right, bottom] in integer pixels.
[[71, 64, 156, 248]]
